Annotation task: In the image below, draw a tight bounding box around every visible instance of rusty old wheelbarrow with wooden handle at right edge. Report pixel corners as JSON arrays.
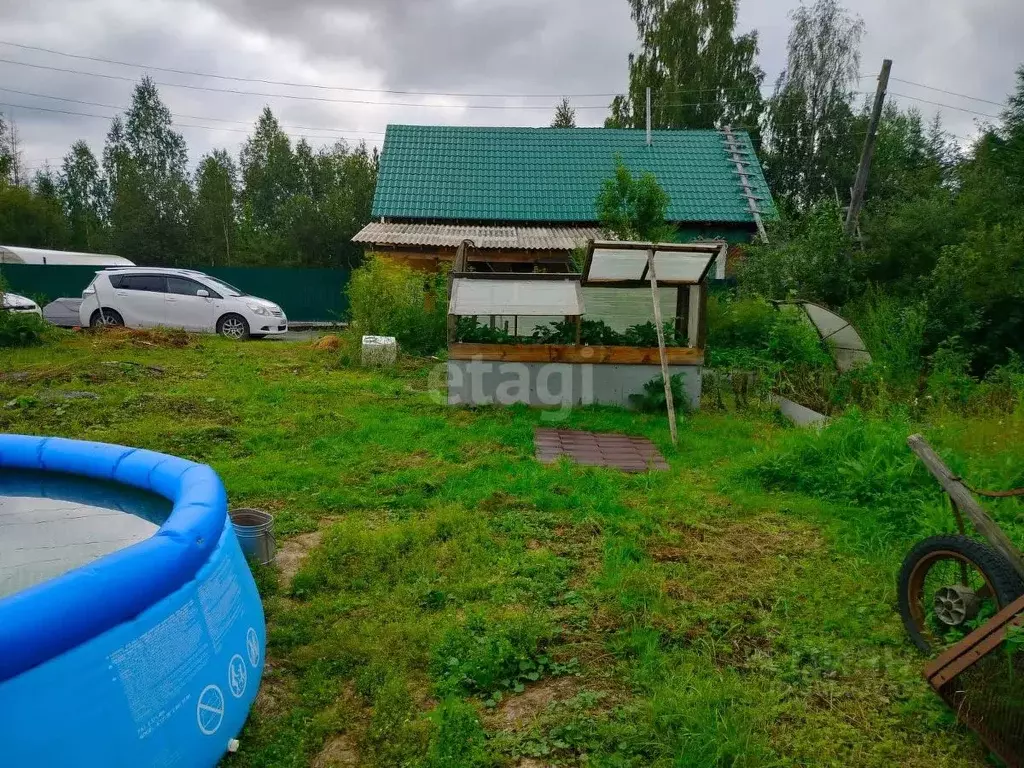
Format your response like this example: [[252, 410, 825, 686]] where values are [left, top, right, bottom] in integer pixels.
[[898, 435, 1024, 766]]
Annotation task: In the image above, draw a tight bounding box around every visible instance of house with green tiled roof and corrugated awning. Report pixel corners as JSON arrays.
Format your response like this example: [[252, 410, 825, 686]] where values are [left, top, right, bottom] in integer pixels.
[[353, 125, 774, 271]]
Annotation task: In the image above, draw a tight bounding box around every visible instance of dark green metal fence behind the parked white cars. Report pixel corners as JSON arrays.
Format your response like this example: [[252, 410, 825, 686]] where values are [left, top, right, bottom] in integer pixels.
[[0, 264, 350, 321]]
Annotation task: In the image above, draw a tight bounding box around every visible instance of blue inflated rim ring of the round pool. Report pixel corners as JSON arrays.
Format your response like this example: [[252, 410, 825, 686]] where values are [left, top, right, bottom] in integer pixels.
[[0, 434, 227, 683]]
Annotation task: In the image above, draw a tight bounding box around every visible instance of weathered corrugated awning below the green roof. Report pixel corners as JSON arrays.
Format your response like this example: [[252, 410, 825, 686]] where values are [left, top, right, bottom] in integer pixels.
[[352, 221, 601, 251]]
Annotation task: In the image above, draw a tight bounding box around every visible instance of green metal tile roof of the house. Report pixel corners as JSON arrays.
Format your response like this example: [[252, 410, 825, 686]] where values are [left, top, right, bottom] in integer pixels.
[[373, 125, 774, 223]]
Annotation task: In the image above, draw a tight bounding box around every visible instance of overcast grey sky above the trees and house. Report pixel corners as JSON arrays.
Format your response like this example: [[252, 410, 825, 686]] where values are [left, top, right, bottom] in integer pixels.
[[0, 0, 1024, 176]]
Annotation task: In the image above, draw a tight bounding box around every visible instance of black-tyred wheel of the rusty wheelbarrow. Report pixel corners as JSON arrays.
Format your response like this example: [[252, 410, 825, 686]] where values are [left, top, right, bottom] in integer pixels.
[[898, 536, 1024, 655]]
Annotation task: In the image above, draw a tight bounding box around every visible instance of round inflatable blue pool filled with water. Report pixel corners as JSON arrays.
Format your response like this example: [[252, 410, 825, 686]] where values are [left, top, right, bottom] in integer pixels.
[[0, 435, 266, 768]]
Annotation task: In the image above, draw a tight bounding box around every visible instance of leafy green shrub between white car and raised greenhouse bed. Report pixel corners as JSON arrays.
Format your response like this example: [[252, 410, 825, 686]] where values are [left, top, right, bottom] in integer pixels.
[[347, 256, 447, 354]]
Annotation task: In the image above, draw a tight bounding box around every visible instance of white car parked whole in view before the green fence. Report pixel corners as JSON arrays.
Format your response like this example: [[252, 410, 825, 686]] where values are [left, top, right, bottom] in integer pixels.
[[79, 266, 288, 339]]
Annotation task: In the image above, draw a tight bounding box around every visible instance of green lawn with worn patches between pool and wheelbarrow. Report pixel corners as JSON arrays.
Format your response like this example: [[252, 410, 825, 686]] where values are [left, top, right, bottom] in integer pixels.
[[0, 336, 1024, 768]]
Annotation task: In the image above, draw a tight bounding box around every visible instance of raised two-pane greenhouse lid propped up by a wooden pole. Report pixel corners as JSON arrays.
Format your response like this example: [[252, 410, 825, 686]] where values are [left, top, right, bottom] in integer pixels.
[[583, 241, 725, 288]]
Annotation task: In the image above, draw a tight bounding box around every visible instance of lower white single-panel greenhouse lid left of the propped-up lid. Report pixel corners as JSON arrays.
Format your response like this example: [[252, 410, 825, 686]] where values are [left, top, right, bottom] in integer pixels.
[[449, 273, 584, 316]]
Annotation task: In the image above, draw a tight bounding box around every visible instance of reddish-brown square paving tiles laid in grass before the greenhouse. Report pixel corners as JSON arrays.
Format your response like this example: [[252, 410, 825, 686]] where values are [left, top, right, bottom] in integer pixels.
[[534, 428, 669, 472]]
